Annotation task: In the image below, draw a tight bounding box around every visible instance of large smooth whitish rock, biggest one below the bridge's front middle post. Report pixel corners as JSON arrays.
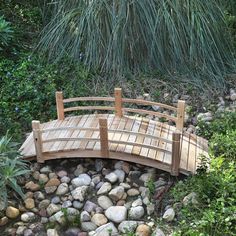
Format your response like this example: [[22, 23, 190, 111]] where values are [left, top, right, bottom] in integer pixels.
[[105, 206, 127, 223]]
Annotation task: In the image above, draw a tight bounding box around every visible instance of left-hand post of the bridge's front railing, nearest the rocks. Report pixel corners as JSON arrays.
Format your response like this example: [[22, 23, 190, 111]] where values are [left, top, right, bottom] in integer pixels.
[[32, 120, 44, 163]]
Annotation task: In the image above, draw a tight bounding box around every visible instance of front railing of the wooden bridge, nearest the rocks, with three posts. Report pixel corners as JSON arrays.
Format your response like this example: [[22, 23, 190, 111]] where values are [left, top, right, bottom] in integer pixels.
[[32, 118, 181, 176]]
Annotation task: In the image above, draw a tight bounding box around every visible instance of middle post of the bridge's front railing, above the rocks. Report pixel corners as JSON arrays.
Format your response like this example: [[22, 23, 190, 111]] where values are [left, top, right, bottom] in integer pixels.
[[99, 118, 109, 157]]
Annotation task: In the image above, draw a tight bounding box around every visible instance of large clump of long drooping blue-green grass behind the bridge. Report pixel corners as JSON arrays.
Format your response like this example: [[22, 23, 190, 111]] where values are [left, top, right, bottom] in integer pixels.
[[39, 0, 235, 87]]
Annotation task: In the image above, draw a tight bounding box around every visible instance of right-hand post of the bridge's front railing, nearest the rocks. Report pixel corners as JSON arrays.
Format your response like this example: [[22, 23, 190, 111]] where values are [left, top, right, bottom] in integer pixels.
[[171, 131, 181, 176]]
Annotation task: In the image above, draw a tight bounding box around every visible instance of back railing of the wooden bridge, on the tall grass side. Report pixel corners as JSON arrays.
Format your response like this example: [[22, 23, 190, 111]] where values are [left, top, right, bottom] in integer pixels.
[[56, 88, 185, 130]]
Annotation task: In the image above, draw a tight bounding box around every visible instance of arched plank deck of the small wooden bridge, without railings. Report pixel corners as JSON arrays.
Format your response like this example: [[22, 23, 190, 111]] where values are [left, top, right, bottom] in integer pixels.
[[20, 114, 207, 174]]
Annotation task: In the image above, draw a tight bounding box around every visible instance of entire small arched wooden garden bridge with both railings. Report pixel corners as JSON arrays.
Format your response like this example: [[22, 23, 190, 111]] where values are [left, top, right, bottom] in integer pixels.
[[20, 88, 208, 176]]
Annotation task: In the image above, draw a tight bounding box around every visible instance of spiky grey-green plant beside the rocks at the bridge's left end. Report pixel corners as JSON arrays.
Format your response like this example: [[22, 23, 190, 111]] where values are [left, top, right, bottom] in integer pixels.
[[0, 135, 29, 210]]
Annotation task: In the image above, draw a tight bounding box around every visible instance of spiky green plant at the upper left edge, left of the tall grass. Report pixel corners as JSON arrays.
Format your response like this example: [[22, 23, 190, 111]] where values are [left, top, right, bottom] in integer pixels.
[[0, 16, 13, 51]]
